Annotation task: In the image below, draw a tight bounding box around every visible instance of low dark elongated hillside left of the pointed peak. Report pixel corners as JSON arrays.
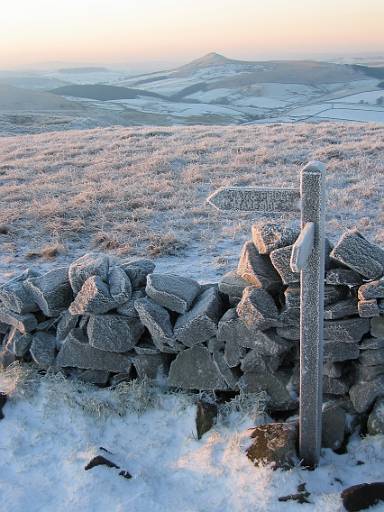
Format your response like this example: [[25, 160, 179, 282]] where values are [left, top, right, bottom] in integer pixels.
[[51, 84, 161, 101]]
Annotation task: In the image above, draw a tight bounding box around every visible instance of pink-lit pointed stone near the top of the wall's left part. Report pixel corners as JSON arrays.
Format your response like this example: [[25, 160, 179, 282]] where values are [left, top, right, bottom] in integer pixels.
[[69, 276, 118, 315]]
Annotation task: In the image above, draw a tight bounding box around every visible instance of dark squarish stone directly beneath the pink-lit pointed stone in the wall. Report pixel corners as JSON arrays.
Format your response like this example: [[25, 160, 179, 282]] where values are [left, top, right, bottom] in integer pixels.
[[87, 314, 144, 352]]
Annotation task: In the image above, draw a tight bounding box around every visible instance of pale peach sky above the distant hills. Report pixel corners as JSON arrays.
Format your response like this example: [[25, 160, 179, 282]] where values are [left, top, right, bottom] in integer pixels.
[[0, 0, 384, 69]]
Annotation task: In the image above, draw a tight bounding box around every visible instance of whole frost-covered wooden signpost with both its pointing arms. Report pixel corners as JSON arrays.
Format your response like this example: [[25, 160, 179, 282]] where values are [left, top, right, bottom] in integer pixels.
[[208, 161, 325, 467]]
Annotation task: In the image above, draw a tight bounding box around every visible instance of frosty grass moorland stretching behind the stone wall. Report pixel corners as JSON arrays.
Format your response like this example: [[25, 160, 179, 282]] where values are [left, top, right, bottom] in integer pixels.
[[0, 123, 384, 278]]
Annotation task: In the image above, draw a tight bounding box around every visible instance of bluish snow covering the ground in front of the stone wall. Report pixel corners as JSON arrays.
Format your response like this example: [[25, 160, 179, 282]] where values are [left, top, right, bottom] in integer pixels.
[[0, 368, 384, 512]]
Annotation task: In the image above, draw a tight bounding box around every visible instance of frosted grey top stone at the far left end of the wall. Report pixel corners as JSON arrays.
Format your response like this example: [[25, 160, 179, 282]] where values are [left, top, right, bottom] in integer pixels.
[[0, 270, 39, 315]]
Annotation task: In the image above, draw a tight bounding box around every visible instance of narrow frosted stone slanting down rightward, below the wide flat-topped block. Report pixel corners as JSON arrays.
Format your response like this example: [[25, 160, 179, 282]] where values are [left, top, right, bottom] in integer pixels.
[[135, 297, 176, 351]]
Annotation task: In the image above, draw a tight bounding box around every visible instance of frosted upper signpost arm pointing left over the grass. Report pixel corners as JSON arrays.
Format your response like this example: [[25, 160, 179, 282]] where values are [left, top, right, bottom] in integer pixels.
[[208, 187, 300, 212]]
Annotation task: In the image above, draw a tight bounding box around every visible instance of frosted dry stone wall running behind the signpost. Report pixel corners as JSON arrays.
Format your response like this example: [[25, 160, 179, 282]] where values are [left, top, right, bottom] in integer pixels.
[[0, 223, 384, 431]]
